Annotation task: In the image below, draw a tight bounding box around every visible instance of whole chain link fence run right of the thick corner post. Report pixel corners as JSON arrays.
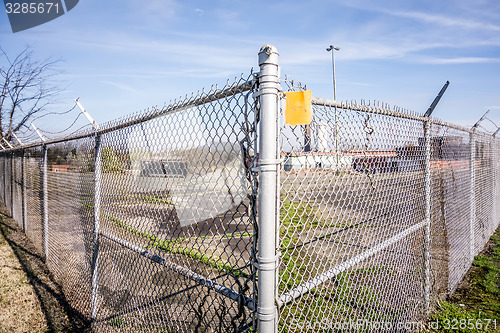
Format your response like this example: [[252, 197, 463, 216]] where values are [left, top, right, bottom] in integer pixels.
[[278, 94, 500, 332]]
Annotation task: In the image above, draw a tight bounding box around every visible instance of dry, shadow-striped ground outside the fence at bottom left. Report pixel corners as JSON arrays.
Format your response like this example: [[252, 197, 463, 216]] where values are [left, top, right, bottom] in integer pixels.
[[0, 204, 90, 332]]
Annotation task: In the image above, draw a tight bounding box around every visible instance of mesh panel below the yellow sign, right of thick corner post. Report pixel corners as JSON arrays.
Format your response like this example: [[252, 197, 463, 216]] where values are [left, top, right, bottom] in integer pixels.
[[279, 99, 424, 332]]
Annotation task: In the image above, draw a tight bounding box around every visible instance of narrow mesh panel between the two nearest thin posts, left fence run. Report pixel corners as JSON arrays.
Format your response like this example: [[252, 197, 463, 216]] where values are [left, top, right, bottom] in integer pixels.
[[42, 137, 94, 318]]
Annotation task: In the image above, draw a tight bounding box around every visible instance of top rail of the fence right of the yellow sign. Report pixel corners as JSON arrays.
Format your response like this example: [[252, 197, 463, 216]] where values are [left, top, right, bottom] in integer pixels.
[[312, 96, 493, 137]]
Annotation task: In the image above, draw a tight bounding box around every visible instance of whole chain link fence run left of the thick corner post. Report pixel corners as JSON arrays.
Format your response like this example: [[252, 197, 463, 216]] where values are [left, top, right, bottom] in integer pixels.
[[0, 75, 256, 332]]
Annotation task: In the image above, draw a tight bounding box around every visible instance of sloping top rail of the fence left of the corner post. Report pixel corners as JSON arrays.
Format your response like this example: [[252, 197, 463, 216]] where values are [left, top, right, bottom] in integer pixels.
[[1, 74, 254, 152]]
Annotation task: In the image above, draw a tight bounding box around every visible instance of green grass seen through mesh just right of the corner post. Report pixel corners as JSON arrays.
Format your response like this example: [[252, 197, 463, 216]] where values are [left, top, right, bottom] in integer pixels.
[[279, 200, 390, 333]]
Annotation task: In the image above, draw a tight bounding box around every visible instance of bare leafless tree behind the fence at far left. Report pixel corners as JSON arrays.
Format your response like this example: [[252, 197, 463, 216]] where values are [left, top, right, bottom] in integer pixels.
[[0, 46, 61, 141]]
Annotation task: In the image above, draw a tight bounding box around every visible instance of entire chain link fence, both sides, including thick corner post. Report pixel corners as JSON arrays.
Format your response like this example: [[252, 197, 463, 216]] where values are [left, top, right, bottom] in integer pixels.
[[0, 46, 500, 333]]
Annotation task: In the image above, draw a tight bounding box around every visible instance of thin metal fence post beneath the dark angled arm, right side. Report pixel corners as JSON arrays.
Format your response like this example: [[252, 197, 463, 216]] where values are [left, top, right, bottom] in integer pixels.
[[424, 121, 431, 319]]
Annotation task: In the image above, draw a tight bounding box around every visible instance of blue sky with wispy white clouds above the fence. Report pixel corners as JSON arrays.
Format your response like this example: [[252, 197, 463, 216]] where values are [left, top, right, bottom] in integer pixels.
[[0, 0, 500, 141]]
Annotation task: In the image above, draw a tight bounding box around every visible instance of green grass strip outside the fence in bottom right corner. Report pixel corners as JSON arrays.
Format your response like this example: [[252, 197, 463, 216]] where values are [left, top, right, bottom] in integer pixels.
[[426, 229, 500, 332]]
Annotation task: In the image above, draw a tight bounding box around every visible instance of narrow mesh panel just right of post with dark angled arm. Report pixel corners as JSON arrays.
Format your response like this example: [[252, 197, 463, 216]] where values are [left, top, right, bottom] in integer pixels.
[[431, 125, 471, 293]]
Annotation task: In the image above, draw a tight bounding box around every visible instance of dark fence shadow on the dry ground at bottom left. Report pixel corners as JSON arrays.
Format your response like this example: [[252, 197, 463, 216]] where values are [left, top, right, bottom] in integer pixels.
[[0, 207, 90, 332]]
